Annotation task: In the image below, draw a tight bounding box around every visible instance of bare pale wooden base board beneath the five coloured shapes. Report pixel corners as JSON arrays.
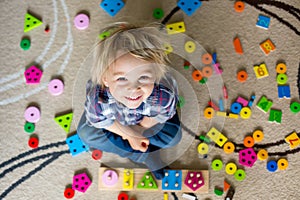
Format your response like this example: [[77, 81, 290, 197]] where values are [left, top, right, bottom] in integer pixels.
[[98, 167, 209, 194]]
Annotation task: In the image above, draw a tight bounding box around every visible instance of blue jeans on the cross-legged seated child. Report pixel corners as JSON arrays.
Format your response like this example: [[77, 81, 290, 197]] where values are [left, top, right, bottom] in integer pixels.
[[77, 112, 182, 169]]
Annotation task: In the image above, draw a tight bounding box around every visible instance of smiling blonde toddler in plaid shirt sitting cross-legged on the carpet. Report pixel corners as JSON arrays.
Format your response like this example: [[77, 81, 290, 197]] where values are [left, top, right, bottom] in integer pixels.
[[77, 23, 181, 179]]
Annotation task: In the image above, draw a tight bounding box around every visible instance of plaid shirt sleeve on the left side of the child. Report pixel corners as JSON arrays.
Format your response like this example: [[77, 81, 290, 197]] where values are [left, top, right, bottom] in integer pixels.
[[84, 81, 114, 128]]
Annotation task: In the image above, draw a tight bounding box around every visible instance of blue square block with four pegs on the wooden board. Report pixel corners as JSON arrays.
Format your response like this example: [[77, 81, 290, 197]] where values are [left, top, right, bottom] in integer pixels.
[[162, 170, 182, 190]]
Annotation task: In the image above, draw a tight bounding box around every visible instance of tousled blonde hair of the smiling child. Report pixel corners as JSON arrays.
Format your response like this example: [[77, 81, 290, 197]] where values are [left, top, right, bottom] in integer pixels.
[[91, 23, 169, 86]]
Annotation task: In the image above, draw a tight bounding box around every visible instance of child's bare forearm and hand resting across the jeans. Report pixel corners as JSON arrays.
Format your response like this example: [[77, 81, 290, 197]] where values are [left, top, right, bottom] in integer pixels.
[[106, 121, 149, 152]]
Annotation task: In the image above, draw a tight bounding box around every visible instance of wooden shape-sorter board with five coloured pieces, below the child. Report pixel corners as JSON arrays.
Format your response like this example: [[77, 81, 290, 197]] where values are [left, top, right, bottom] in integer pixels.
[[98, 166, 209, 193]]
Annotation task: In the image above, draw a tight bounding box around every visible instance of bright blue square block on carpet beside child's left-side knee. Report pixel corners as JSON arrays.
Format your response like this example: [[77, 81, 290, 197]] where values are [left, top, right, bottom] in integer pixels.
[[66, 134, 89, 156]]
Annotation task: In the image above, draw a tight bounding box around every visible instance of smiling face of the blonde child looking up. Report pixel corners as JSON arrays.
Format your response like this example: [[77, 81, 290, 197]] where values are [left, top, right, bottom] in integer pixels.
[[103, 53, 156, 109]]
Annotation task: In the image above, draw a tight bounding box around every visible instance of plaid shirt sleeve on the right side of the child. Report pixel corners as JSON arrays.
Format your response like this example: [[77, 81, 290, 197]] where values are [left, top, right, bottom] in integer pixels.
[[153, 75, 178, 123]]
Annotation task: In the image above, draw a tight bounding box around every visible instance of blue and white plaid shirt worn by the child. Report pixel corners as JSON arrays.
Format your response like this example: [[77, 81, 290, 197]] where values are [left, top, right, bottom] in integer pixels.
[[85, 73, 178, 128]]
